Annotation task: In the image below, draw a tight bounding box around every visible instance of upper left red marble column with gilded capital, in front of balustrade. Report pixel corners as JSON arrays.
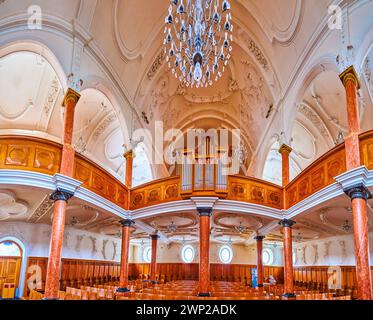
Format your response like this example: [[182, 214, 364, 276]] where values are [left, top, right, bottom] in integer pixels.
[[60, 89, 80, 177]]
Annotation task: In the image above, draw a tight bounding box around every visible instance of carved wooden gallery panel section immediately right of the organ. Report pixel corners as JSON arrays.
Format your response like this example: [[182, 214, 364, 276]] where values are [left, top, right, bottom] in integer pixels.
[[227, 176, 283, 209]]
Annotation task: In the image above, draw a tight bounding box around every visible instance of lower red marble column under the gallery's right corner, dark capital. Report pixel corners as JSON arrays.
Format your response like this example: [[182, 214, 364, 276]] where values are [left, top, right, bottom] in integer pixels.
[[279, 219, 295, 298]]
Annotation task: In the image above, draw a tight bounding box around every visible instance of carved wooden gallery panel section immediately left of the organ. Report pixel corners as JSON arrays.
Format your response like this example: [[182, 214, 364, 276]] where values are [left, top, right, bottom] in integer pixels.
[[130, 177, 181, 210]]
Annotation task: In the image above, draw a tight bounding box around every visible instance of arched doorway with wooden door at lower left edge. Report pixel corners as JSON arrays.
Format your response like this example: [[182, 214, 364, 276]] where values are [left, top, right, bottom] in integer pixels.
[[0, 239, 24, 299]]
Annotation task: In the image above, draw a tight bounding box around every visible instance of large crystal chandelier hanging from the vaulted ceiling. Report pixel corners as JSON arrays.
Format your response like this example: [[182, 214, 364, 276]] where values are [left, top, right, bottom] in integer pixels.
[[164, 0, 233, 88]]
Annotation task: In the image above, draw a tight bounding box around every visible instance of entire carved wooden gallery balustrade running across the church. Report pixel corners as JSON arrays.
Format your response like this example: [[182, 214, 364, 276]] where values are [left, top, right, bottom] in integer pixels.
[[0, 131, 373, 214]]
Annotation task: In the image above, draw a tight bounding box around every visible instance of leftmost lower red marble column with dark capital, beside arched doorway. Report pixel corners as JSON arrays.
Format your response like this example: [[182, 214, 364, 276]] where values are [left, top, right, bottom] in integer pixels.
[[44, 189, 73, 300]]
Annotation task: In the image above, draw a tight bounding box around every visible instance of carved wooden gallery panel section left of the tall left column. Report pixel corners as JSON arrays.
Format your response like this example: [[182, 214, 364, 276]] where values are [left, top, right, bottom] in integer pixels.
[[0, 136, 62, 175]]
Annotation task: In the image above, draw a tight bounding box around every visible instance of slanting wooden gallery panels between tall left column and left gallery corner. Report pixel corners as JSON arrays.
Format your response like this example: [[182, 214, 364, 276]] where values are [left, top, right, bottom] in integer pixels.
[[74, 155, 129, 209]]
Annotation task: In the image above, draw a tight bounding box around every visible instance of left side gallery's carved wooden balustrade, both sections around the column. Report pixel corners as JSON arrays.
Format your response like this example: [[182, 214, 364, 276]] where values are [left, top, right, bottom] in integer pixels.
[[0, 136, 129, 209]]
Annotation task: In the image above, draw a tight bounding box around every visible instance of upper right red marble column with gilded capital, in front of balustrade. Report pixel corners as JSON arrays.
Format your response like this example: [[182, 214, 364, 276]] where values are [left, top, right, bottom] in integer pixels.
[[339, 66, 361, 171]]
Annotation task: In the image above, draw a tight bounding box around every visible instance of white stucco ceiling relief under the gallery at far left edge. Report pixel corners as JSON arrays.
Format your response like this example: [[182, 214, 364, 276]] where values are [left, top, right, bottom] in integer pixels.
[[0, 190, 28, 221]]
